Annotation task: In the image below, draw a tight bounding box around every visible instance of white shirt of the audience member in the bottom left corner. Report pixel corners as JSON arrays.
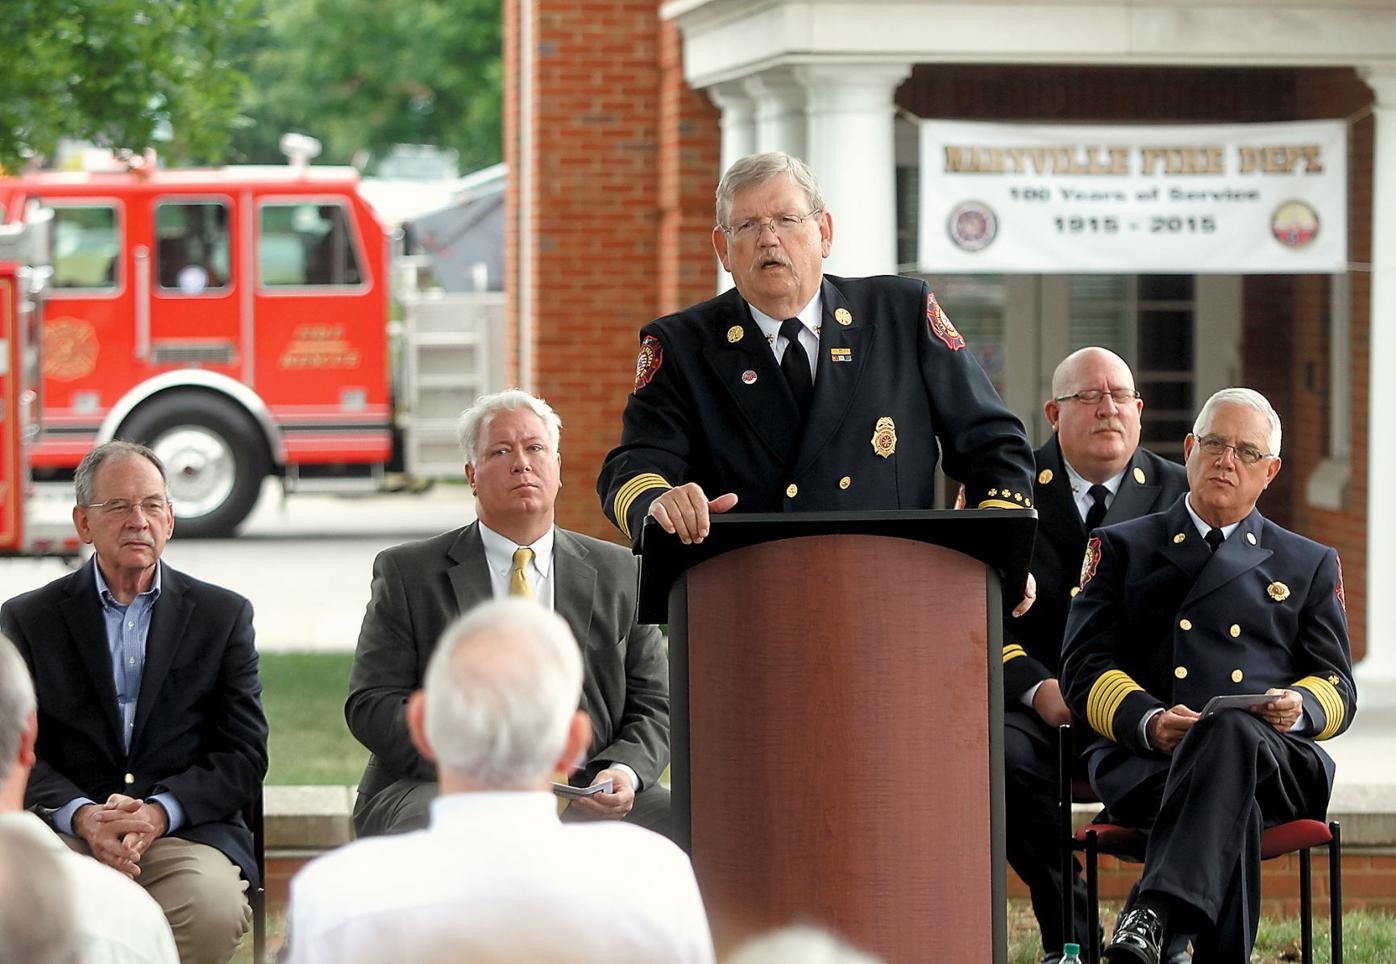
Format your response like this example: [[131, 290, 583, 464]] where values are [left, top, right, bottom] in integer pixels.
[[0, 813, 179, 964]]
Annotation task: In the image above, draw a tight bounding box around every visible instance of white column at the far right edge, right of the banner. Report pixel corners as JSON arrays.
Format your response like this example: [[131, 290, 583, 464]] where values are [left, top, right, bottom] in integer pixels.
[[1358, 70, 1396, 705]]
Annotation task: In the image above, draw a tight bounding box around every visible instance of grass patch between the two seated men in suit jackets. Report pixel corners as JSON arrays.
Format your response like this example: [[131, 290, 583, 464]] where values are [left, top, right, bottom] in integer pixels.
[[261, 653, 369, 787]]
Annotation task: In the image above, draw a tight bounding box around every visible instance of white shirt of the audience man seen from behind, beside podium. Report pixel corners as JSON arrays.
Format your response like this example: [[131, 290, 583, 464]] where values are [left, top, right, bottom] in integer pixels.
[[288, 792, 713, 964]]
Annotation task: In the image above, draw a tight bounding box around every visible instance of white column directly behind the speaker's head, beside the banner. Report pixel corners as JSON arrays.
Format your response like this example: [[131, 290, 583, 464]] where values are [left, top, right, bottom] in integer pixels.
[[796, 64, 912, 275]]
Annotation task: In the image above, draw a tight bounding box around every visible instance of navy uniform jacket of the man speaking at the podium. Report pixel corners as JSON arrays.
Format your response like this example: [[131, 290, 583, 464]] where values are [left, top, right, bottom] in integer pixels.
[[596, 276, 1032, 539]]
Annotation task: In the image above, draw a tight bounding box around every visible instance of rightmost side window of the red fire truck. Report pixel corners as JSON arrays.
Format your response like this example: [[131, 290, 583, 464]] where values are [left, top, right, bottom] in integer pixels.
[[257, 202, 363, 287]]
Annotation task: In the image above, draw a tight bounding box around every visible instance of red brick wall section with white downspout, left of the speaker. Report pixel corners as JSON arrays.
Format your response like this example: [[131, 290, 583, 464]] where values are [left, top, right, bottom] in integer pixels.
[[504, 0, 718, 540]]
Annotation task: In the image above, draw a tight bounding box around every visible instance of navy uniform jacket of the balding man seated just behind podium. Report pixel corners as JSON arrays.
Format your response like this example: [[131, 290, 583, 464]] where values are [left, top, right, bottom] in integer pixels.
[[1004, 434, 1188, 706]]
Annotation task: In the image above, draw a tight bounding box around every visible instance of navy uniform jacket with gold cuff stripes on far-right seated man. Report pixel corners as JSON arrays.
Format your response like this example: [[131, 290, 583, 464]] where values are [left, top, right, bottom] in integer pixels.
[[1061, 499, 1357, 805]]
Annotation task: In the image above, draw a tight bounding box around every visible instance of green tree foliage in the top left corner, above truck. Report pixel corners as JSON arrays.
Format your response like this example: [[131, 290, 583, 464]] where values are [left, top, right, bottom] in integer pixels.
[[0, 0, 254, 170]]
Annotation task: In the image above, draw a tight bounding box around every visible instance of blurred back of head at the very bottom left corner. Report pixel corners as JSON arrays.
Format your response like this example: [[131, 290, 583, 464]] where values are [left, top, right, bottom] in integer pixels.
[[0, 827, 78, 964]]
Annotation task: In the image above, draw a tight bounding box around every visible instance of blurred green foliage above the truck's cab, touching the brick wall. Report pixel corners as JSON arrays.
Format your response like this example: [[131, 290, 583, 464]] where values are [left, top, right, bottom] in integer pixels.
[[233, 0, 503, 170]]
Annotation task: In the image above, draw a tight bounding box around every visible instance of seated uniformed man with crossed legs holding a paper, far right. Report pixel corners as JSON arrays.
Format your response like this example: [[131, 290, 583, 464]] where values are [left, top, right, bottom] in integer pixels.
[[1061, 388, 1357, 964]]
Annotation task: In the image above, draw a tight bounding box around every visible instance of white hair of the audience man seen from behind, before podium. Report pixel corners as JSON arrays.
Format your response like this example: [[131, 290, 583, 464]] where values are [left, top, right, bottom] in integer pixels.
[[423, 598, 582, 790]]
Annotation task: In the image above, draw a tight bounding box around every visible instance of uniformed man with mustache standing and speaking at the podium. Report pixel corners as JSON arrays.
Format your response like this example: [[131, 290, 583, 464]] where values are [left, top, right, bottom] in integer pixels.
[[597, 152, 1032, 569]]
